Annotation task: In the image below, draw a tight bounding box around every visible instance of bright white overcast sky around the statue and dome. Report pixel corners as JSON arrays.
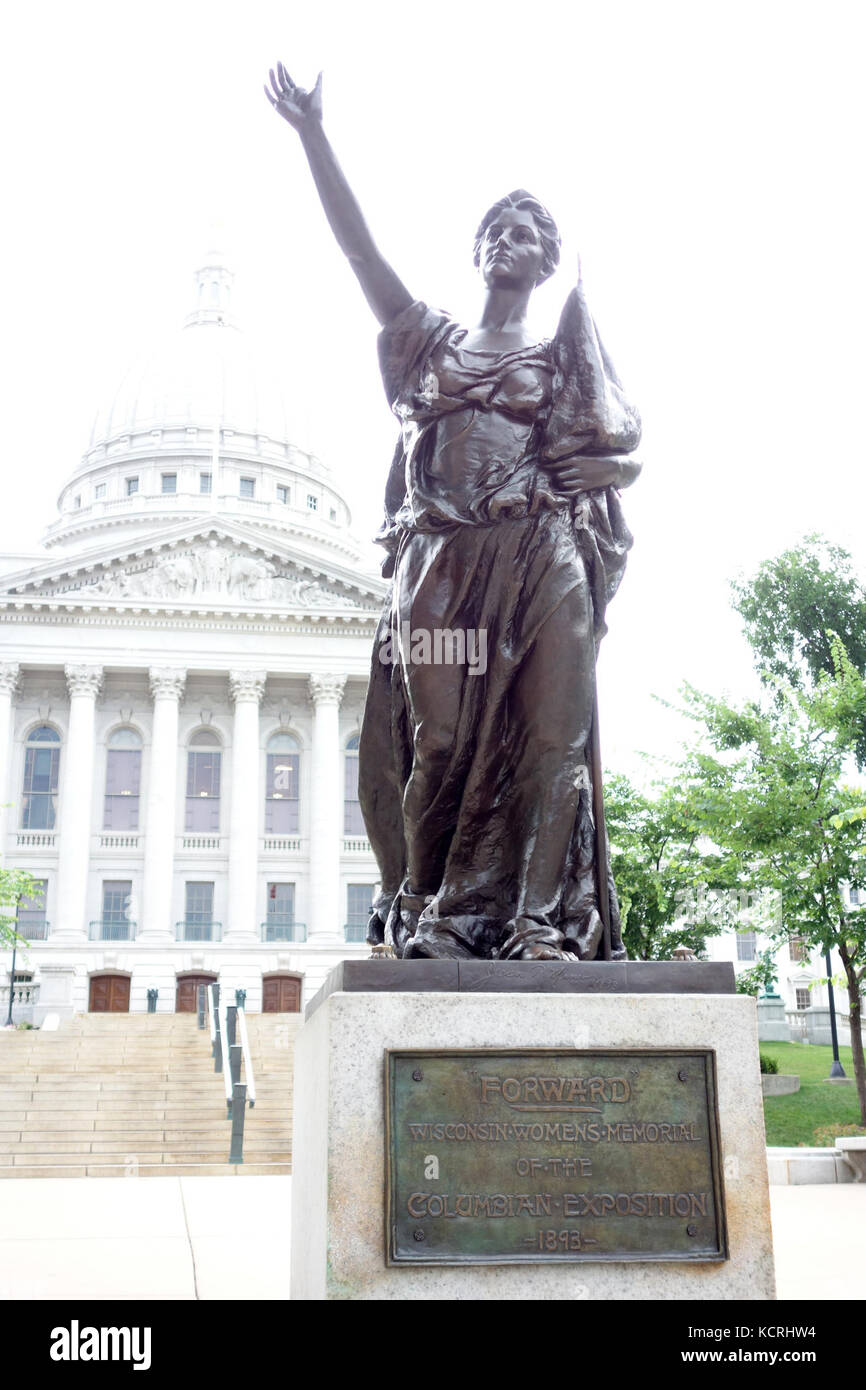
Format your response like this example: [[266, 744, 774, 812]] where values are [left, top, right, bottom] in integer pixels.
[[0, 0, 866, 769]]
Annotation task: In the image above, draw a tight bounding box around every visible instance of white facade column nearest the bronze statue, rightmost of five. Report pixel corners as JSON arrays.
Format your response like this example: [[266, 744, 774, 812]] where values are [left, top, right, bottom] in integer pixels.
[[309, 676, 346, 945]]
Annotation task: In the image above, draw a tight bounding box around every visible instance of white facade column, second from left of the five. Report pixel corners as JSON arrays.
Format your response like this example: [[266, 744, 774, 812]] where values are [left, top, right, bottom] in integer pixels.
[[51, 666, 103, 942]]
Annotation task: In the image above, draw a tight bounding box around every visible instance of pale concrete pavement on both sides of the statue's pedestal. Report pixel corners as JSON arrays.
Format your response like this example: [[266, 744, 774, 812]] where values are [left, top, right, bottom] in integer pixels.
[[0, 1177, 866, 1302]]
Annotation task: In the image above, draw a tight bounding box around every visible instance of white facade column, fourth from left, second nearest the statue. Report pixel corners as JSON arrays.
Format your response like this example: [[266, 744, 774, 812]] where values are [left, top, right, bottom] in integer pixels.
[[225, 671, 267, 942]]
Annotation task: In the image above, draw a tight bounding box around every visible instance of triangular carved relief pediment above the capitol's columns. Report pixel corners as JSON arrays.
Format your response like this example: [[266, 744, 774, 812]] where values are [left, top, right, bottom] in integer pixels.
[[8, 538, 377, 612]]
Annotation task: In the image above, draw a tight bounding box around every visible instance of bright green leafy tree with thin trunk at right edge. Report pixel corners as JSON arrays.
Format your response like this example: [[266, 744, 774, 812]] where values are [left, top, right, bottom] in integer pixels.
[[684, 639, 866, 1125]]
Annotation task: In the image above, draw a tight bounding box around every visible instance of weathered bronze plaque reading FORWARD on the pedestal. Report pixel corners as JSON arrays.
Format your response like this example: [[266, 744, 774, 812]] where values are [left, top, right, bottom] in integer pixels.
[[385, 1048, 727, 1265]]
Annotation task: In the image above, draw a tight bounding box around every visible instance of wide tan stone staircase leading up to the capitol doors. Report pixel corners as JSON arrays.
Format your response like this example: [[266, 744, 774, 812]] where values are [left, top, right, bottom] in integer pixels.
[[0, 1013, 302, 1179]]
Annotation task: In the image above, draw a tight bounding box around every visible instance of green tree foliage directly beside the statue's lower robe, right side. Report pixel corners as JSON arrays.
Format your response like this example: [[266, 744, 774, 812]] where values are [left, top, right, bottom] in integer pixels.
[[605, 776, 734, 960]]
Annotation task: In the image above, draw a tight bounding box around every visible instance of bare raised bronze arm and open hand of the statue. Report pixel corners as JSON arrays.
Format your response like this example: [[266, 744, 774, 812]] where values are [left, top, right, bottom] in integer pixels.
[[264, 63, 413, 324]]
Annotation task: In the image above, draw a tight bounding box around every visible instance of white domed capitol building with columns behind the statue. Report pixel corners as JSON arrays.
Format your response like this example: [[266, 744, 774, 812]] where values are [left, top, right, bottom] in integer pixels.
[[0, 254, 385, 1023]]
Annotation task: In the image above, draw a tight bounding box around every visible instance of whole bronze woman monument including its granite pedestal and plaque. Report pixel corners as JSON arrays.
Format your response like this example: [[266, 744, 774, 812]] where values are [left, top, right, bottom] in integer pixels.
[[265, 65, 773, 1298]]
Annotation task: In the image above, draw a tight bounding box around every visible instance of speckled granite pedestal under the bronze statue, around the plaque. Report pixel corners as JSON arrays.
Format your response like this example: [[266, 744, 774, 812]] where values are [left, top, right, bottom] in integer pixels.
[[292, 960, 774, 1301]]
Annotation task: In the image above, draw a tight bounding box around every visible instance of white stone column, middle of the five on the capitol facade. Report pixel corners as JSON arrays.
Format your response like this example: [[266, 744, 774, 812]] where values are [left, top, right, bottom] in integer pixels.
[[139, 666, 186, 941]]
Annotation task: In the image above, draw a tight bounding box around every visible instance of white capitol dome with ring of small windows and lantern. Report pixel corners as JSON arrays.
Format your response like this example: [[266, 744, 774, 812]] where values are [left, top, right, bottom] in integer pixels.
[[44, 253, 356, 549]]
